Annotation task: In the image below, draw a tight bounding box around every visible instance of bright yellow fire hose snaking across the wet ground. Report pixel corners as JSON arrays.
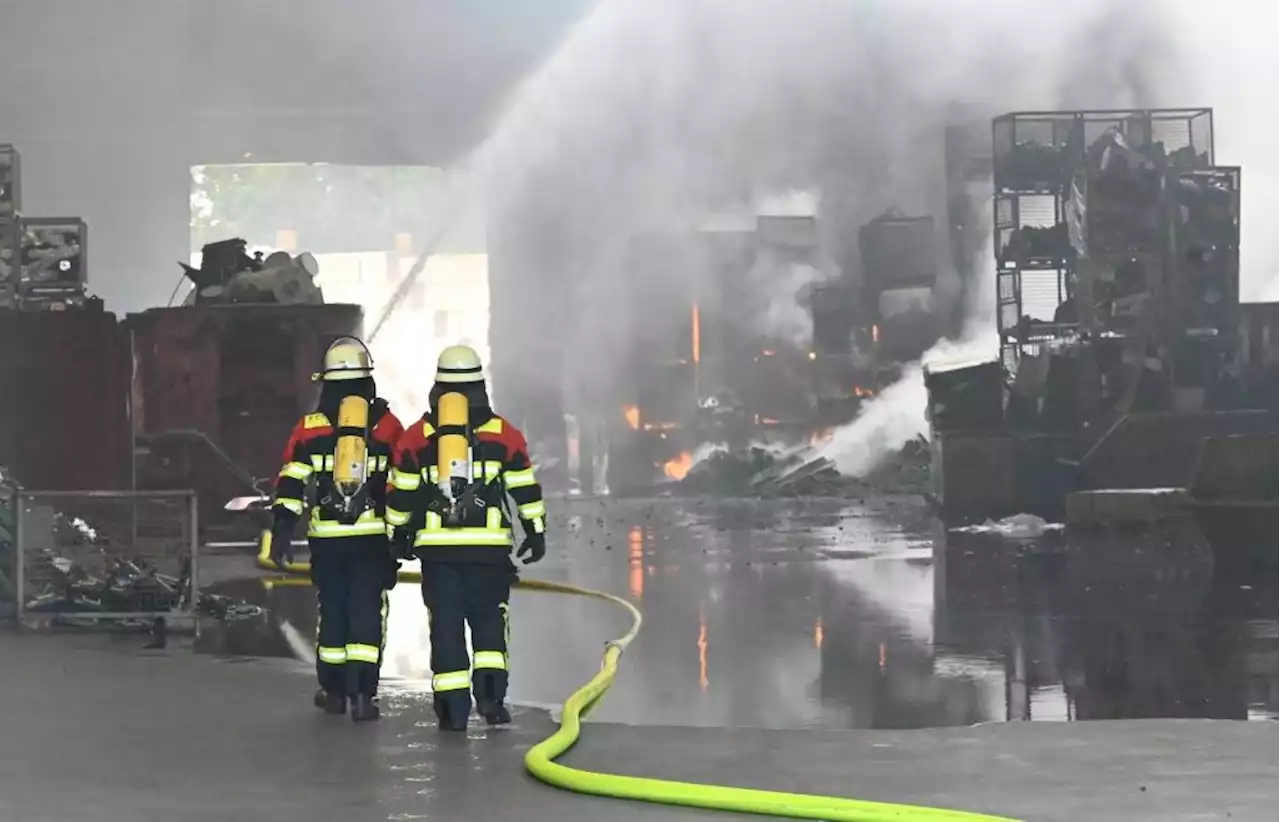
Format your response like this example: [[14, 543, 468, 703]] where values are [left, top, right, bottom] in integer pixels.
[[257, 539, 1016, 822]]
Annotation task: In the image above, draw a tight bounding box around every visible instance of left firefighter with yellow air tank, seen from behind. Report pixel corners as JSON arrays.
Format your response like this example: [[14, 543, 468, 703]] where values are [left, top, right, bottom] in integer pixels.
[[270, 337, 403, 722]]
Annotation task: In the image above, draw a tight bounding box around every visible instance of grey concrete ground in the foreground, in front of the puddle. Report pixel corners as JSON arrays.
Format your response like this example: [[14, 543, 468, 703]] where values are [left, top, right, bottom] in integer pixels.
[[0, 631, 1280, 822]]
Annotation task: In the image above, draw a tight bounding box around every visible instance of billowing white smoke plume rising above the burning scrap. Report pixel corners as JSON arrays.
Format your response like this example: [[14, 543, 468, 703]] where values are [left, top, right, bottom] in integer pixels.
[[455, 0, 1233, 460]]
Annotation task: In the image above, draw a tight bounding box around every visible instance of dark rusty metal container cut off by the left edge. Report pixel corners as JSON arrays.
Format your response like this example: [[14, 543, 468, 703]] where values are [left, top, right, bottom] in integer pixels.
[[0, 301, 129, 490]]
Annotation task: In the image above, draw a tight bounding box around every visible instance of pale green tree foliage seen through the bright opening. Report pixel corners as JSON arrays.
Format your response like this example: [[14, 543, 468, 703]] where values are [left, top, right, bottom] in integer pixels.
[[191, 164, 448, 254]]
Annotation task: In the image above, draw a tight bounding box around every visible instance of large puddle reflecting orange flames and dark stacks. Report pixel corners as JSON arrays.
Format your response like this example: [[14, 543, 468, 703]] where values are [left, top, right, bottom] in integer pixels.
[[201, 499, 1280, 729]]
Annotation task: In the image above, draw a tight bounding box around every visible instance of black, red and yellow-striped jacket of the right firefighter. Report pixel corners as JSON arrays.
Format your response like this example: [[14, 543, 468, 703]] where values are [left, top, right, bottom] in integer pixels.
[[387, 412, 547, 563]]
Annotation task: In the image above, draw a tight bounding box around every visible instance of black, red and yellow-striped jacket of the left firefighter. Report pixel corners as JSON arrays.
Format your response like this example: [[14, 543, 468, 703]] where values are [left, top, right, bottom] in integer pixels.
[[271, 399, 404, 539]]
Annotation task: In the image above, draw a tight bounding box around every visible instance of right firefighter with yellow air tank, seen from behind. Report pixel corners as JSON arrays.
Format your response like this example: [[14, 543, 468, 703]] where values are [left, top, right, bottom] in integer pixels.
[[387, 346, 547, 731]]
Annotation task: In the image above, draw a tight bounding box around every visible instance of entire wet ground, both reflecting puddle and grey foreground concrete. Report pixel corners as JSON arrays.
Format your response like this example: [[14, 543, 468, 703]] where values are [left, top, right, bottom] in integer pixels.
[[0, 491, 1280, 822]]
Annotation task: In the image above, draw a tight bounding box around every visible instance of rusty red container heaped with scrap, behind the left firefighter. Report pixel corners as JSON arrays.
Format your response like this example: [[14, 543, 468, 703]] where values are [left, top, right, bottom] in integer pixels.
[[125, 303, 364, 520]]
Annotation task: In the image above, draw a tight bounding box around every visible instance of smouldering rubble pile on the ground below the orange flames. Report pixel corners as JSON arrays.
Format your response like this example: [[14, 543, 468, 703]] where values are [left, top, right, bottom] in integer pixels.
[[676, 437, 929, 497]]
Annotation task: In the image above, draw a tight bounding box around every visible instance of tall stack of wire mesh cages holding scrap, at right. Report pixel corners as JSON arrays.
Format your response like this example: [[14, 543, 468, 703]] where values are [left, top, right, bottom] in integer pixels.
[[992, 109, 1213, 370]]
